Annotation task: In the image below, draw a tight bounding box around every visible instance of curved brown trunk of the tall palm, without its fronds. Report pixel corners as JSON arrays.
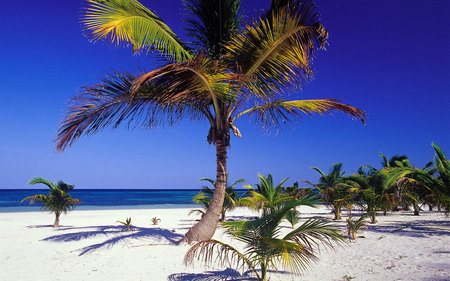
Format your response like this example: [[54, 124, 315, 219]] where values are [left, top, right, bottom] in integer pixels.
[[180, 134, 227, 244]]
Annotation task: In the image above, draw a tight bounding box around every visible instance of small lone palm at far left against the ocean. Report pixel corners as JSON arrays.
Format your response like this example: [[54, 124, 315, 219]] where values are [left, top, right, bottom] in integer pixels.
[[20, 177, 81, 228]]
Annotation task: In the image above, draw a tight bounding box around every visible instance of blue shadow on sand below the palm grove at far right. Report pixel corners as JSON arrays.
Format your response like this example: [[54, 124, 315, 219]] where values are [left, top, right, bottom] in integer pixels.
[[369, 220, 450, 237]]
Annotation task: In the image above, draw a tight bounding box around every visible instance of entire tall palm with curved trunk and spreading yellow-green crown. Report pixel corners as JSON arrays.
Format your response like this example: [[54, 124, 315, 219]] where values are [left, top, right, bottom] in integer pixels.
[[56, 0, 365, 242]]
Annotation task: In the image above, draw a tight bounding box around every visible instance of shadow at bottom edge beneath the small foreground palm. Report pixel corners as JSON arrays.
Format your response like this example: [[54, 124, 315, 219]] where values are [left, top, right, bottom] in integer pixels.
[[167, 268, 257, 281]]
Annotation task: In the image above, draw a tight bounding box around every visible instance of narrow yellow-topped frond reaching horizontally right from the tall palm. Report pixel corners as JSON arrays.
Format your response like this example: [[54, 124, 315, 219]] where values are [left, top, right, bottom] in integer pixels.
[[233, 99, 366, 132]]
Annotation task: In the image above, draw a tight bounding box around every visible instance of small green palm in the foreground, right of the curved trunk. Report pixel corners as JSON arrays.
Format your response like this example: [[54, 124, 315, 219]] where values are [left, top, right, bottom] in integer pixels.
[[184, 198, 344, 280]]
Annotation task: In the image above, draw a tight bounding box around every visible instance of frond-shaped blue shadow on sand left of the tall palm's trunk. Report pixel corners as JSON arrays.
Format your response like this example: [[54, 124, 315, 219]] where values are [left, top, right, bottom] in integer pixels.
[[42, 225, 183, 256]]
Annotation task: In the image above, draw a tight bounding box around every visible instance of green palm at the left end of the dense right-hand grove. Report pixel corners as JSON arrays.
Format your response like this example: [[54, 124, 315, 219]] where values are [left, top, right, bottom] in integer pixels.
[[312, 163, 356, 220]]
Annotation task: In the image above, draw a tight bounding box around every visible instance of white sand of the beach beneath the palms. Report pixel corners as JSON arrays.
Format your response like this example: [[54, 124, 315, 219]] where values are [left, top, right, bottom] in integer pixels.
[[0, 207, 450, 281]]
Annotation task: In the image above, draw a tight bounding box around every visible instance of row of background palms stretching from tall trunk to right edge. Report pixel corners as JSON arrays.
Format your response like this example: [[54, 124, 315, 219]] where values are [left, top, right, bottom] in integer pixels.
[[191, 144, 450, 225]]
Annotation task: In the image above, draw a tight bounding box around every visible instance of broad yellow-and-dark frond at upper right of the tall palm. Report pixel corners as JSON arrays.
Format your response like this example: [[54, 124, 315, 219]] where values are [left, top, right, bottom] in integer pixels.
[[227, 0, 328, 99]]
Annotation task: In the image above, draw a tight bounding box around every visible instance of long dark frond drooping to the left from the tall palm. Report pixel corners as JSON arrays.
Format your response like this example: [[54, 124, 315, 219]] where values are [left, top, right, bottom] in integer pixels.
[[55, 68, 207, 151]]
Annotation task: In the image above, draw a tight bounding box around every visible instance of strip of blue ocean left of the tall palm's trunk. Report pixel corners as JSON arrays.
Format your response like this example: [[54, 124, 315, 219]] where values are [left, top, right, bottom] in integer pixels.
[[0, 189, 207, 212]]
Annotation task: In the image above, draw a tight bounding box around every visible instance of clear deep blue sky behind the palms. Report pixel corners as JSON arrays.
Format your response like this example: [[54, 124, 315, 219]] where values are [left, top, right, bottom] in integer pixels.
[[0, 0, 450, 189]]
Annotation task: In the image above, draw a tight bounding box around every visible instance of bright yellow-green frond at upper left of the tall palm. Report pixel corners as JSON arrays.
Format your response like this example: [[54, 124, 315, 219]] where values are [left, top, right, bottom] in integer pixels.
[[81, 0, 191, 61]]
